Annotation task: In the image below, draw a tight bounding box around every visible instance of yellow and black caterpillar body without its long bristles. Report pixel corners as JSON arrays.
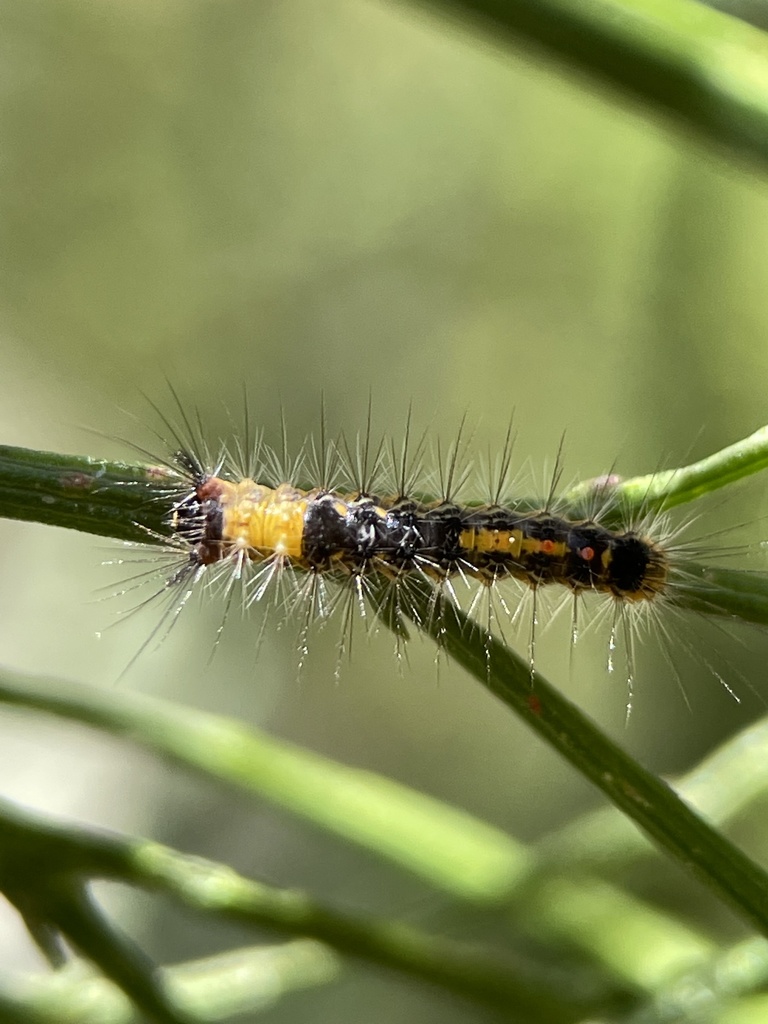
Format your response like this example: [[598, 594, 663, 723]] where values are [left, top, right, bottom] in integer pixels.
[[170, 453, 669, 602]]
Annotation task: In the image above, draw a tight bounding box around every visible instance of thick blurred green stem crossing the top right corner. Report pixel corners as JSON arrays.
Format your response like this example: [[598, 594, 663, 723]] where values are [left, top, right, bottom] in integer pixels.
[[415, 0, 768, 168]]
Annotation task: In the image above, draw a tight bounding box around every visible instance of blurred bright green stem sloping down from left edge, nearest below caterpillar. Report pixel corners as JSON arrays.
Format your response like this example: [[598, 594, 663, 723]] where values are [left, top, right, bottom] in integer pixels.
[[0, 670, 529, 903]]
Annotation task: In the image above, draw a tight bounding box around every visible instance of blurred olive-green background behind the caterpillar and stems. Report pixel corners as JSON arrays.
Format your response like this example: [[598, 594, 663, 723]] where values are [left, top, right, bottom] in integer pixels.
[[0, 0, 768, 1024]]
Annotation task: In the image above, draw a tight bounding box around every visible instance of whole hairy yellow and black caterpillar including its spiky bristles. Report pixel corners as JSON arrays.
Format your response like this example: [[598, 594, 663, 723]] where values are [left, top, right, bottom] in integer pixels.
[[115, 402, 768, 714]]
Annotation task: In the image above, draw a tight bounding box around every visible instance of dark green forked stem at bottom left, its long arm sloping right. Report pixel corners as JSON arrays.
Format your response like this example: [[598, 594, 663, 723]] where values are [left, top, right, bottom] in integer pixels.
[[0, 801, 597, 1024]]
